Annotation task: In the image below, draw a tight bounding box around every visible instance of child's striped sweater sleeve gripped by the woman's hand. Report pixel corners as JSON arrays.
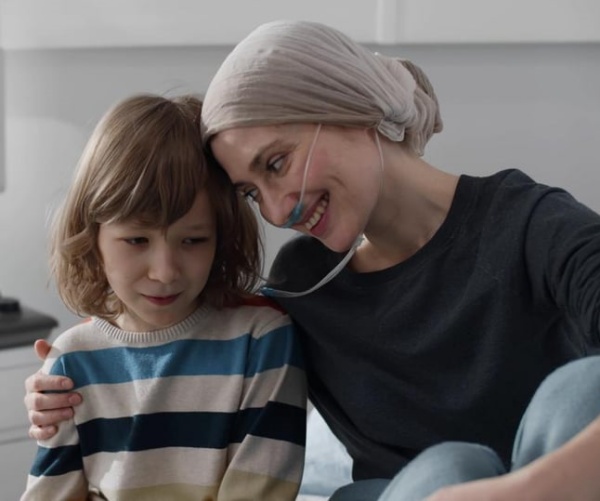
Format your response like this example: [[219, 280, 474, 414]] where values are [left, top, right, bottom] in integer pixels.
[[21, 348, 88, 501]]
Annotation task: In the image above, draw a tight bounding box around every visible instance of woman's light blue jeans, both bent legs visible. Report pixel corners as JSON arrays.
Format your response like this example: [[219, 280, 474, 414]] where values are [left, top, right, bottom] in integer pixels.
[[330, 356, 600, 501]]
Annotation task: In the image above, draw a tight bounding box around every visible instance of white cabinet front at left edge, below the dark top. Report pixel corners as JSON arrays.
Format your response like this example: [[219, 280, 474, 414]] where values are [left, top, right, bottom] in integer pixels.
[[0, 346, 41, 500]]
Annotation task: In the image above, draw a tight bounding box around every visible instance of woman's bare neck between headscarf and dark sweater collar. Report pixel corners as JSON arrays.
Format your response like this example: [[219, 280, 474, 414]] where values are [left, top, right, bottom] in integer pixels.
[[351, 152, 458, 272]]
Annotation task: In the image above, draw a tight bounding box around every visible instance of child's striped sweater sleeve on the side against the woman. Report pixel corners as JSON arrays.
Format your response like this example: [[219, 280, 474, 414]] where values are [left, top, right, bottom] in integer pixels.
[[218, 309, 306, 501]]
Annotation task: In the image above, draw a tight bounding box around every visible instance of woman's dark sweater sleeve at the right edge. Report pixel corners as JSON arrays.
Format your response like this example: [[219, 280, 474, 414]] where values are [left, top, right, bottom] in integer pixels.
[[525, 190, 600, 346]]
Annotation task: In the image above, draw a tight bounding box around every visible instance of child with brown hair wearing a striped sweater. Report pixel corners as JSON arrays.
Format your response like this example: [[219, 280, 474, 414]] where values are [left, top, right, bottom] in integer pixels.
[[22, 95, 306, 501]]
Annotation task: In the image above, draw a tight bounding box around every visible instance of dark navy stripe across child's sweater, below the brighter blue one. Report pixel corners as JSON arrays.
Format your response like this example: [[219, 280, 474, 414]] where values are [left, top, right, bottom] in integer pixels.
[[77, 402, 306, 456]]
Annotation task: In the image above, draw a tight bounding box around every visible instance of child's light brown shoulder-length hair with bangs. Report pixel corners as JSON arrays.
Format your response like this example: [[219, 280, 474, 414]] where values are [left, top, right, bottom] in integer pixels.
[[50, 94, 262, 318]]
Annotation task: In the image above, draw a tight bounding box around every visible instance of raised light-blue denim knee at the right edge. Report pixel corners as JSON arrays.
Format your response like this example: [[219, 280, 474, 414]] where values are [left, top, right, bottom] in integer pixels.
[[512, 356, 600, 469]]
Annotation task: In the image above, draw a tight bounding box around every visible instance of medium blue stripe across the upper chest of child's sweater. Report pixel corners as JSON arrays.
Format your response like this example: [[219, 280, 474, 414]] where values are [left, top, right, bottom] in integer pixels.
[[50, 325, 303, 388]]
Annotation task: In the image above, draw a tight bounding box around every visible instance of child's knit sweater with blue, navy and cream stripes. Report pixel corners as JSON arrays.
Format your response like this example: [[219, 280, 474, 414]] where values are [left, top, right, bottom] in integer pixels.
[[21, 298, 306, 501]]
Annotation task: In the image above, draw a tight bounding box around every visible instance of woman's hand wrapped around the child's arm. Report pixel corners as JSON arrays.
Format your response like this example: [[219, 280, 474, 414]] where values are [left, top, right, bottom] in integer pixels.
[[25, 339, 82, 440]]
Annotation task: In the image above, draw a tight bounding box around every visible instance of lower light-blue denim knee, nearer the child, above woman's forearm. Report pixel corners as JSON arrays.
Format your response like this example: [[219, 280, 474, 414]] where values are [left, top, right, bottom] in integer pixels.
[[379, 442, 506, 501]]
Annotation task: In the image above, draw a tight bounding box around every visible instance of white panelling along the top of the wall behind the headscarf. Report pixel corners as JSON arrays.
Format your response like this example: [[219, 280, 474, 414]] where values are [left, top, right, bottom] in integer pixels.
[[0, 0, 600, 49]]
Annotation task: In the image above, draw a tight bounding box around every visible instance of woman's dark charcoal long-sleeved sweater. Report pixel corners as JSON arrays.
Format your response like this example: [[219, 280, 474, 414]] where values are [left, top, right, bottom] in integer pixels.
[[270, 170, 600, 480]]
